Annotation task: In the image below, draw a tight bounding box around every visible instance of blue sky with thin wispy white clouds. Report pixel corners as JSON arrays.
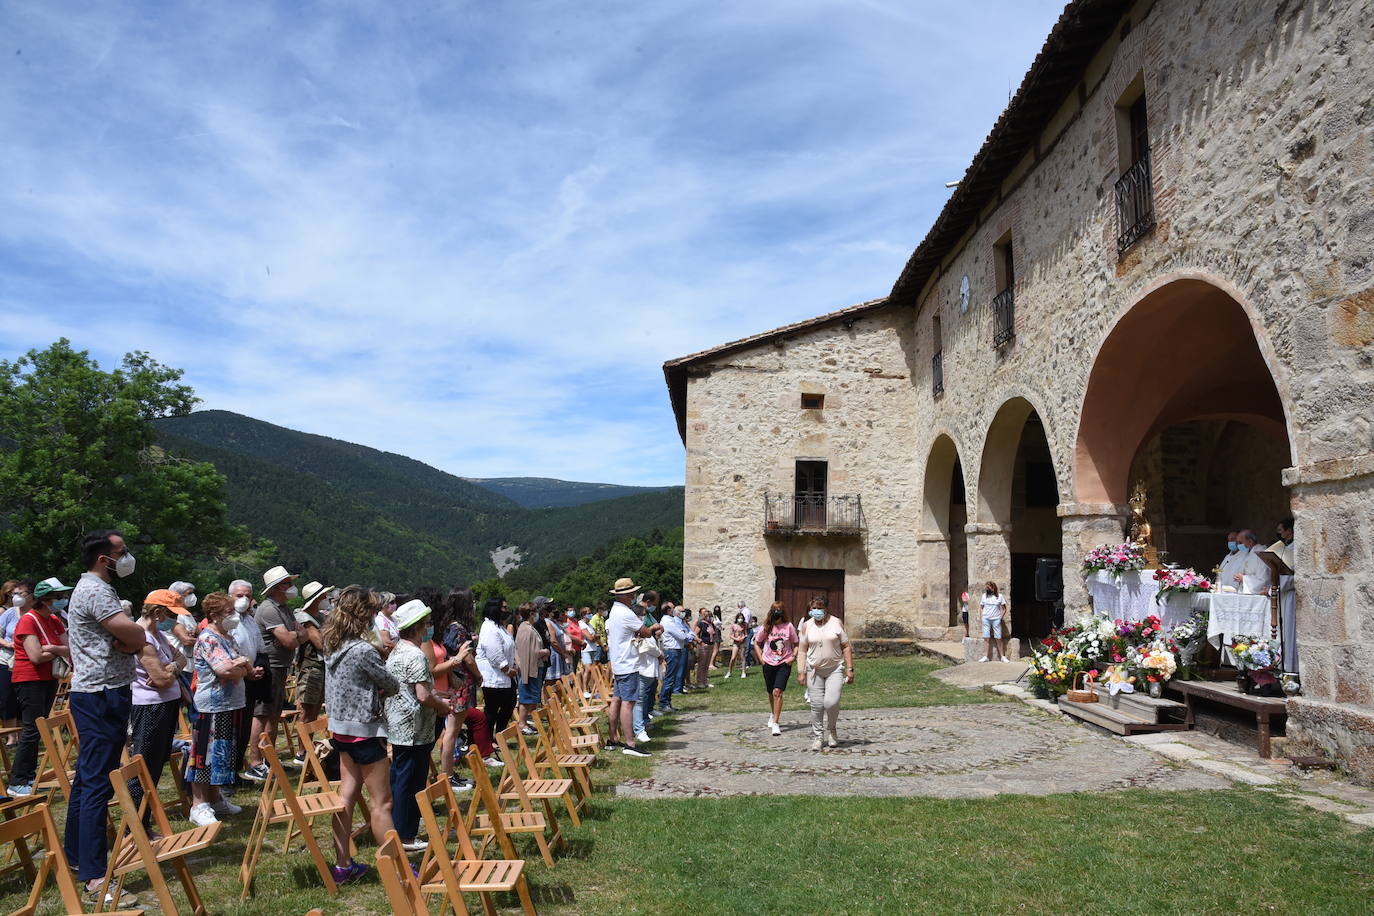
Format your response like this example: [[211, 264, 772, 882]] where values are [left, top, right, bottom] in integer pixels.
[[0, 0, 1062, 483]]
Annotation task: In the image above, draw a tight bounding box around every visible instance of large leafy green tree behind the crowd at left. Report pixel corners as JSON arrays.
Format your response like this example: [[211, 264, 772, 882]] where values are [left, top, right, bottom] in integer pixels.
[[0, 339, 272, 599]]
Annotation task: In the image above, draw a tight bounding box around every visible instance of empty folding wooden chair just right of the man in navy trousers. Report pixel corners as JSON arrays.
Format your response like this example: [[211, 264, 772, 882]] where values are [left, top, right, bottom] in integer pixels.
[[98, 754, 224, 916]]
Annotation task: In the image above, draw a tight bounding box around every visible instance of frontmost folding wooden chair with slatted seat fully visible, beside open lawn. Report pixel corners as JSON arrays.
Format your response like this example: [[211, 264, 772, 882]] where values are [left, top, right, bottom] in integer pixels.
[[415, 779, 534, 913]]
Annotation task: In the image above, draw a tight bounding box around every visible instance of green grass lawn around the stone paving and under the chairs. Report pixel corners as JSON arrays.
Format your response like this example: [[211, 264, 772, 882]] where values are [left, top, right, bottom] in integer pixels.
[[0, 659, 1374, 916]]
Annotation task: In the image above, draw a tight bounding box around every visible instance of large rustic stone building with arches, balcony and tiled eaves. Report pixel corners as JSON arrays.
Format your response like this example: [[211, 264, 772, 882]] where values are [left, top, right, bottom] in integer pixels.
[[664, 0, 1374, 779]]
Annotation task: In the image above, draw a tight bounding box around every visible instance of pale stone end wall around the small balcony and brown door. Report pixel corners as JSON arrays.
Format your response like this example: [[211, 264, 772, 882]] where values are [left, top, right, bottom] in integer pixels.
[[683, 309, 917, 632]]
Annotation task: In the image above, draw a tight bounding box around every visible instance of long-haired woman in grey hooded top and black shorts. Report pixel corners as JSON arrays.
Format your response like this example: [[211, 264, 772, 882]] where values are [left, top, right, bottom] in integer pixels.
[[320, 585, 401, 884]]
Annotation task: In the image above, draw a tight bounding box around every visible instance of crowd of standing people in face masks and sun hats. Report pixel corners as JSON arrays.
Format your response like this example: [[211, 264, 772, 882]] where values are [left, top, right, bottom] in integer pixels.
[[0, 530, 855, 906]]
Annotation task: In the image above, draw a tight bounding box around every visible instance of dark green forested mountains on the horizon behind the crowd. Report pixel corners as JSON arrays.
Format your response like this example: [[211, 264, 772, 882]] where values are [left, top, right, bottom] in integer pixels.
[[157, 411, 683, 592]]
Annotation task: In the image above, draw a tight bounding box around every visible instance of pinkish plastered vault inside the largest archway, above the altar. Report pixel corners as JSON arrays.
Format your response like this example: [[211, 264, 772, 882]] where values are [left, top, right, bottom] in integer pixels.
[[1073, 275, 1293, 505]]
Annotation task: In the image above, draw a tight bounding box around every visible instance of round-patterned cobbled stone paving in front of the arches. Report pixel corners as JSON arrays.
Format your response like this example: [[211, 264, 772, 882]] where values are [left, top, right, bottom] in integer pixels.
[[617, 703, 1228, 798]]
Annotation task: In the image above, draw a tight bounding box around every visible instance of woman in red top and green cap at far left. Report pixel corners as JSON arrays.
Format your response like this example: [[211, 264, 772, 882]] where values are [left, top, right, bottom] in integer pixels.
[[10, 578, 71, 795]]
